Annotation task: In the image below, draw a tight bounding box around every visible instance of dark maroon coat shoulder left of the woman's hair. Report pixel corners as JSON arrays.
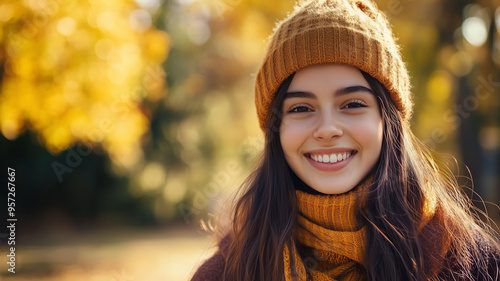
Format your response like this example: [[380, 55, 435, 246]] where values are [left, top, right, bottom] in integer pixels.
[[191, 234, 231, 281]]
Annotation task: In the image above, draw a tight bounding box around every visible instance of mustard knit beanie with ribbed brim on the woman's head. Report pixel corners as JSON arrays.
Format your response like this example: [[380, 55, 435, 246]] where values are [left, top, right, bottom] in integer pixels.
[[255, 0, 412, 130]]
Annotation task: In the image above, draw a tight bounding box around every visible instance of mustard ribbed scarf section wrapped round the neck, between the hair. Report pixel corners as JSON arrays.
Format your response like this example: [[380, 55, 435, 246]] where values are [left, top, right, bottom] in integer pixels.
[[283, 180, 366, 281]]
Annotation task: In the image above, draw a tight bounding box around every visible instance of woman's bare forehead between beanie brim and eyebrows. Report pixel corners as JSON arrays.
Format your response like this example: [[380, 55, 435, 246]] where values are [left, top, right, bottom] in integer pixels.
[[288, 63, 370, 91]]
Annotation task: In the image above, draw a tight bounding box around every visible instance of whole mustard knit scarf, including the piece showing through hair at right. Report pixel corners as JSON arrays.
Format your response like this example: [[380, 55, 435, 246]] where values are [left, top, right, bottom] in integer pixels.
[[283, 181, 449, 281]]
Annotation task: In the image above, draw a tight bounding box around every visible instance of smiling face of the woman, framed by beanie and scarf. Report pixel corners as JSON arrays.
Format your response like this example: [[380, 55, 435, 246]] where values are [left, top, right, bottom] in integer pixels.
[[280, 64, 383, 194]]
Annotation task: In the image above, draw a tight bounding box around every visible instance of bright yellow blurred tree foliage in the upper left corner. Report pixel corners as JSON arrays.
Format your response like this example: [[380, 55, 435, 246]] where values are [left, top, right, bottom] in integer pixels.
[[0, 0, 170, 161]]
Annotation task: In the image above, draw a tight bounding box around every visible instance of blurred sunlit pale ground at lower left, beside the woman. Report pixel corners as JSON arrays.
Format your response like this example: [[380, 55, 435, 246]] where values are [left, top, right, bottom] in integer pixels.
[[0, 226, 216, 281]]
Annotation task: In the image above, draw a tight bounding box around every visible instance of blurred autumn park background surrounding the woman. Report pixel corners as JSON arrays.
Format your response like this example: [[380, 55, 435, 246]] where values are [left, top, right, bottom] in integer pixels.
[[0, 0, 500, 281]]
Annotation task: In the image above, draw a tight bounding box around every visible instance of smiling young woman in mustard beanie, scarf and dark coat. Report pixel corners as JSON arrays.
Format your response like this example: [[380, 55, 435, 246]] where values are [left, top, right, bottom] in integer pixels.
[[192, 0, 500, 281]]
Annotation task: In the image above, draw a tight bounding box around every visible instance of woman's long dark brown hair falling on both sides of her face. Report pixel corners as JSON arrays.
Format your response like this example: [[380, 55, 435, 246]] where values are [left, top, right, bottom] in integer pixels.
[[224, 72, 498, 281]]
